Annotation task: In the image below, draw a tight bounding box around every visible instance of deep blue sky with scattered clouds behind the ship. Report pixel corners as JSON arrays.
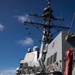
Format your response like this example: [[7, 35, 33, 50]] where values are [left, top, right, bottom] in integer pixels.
[[0, 0, 75, 75]]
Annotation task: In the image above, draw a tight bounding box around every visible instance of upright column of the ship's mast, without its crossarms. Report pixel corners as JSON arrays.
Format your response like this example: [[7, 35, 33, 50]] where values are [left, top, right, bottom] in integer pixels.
[[38, 0, 52, 69]]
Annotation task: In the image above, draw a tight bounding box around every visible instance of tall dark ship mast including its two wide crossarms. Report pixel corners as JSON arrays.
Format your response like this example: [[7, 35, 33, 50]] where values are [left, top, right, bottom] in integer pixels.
[[24, 0, 69, 69]]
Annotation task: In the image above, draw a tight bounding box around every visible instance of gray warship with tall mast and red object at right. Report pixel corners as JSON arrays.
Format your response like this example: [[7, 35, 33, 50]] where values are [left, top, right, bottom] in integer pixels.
[[16, 0, 75, 75]]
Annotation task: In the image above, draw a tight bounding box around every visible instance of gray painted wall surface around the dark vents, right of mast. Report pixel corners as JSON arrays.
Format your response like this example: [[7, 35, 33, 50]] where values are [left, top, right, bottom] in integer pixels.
[[45, 32, 75, 71]]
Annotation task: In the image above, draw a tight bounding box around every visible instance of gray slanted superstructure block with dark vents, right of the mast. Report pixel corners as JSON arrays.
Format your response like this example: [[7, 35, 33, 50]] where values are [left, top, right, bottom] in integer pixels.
[[45, 32, 75, 72]]
